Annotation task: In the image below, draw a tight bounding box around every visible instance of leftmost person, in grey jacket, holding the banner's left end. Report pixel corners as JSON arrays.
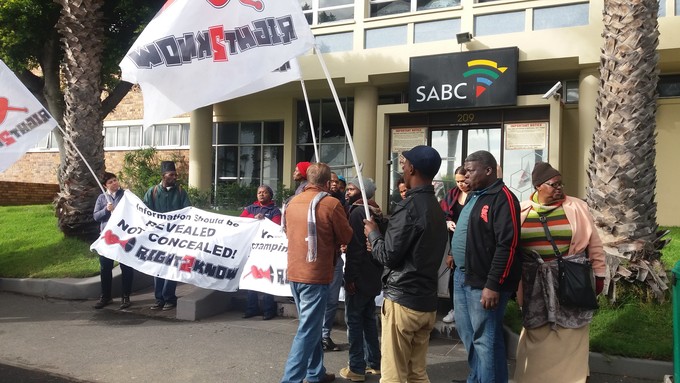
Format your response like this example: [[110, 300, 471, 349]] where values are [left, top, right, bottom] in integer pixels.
[[92, 172, 134, 310]]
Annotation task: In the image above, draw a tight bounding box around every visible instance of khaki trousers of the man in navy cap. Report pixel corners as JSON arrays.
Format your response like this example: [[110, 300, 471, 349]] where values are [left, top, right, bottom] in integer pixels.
[[380, 299, 437, 383]]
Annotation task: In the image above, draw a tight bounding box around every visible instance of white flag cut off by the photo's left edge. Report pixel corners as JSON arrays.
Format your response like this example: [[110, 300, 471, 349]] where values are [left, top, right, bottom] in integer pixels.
[[0, 60, 57, 173]]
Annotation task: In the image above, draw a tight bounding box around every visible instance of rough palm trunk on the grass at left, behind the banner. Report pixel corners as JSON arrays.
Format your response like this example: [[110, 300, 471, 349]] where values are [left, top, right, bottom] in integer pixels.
[[55, 0, 104, 239]]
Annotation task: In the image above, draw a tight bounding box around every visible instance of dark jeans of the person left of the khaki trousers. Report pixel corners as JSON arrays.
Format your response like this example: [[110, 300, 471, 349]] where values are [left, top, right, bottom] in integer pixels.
[[345, 294, 380, 375]]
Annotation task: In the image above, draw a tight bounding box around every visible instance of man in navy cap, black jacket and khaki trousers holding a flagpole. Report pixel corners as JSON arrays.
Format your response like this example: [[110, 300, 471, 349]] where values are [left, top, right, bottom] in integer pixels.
[[364, 145, 448, 382]]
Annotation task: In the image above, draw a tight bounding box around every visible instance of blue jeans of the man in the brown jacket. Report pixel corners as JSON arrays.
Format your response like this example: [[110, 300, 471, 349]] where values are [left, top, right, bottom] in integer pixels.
[[281, 282, 328, 383]]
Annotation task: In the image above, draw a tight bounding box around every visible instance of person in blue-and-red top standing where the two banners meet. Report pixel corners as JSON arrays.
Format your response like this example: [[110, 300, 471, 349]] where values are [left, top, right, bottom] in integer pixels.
[[241, 185, 281, 320]]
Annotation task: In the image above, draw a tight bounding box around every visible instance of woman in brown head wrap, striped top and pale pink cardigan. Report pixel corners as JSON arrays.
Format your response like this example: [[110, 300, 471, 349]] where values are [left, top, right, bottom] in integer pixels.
[[515, 162, 605, 383]]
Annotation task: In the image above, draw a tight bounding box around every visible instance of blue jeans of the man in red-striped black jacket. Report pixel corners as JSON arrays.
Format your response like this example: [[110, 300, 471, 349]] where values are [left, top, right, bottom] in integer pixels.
[[453, 269, 511, 383]]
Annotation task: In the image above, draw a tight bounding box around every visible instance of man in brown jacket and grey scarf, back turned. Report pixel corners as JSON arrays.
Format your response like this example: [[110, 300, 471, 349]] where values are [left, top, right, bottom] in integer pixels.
[[281, 163, 354, 383]]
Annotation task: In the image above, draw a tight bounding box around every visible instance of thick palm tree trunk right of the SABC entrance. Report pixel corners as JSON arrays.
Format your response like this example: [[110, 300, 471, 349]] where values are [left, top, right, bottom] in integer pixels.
[[586, 0, 668, 300]]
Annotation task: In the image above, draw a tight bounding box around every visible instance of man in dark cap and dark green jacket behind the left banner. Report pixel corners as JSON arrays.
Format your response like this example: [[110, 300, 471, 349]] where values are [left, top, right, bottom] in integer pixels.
[[144, 161, 191, 310]]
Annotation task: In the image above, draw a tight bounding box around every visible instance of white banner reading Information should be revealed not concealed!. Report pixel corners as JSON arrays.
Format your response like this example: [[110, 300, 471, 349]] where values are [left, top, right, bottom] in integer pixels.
[[90, 191, 281, 291]]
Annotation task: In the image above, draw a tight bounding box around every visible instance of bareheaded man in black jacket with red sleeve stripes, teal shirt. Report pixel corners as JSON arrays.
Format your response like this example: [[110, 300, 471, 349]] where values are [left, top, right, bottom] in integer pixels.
[[451, 150, 522, 383]]
